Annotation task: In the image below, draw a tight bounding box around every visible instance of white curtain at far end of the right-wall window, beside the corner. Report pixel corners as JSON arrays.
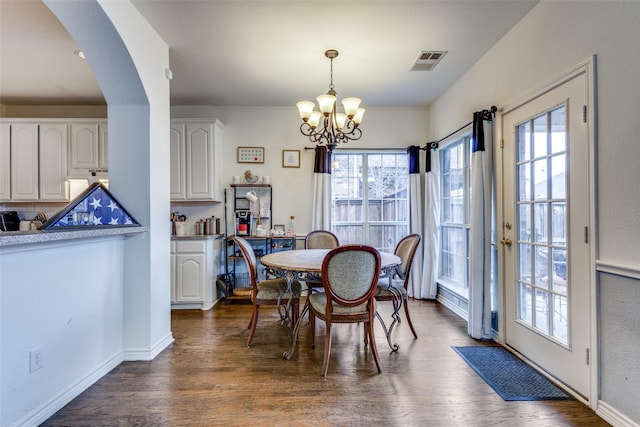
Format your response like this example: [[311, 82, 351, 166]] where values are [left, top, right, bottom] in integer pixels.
[[419, 144, 440, 299]]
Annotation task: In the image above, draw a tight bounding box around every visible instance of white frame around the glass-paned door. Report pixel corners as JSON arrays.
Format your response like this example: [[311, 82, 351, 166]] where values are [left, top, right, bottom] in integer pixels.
[[494, 55, 599, 410]]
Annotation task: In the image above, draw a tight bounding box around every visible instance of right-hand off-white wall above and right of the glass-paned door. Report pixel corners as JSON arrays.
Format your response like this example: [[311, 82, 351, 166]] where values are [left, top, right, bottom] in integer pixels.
[[430, 1, 640, 423]]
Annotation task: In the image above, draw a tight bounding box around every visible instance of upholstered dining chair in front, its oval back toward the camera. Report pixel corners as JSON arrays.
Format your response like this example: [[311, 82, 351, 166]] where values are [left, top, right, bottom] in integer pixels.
[[309, 245, 382, 377]]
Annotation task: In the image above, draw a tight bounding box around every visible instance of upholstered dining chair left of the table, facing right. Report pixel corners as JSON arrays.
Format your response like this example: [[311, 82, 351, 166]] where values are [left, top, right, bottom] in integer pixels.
[[233, 236, 302, 347]]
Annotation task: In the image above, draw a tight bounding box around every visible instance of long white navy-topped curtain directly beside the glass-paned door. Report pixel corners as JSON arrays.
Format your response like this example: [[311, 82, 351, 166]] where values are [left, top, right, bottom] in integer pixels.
[[468, 110, 494, 339]]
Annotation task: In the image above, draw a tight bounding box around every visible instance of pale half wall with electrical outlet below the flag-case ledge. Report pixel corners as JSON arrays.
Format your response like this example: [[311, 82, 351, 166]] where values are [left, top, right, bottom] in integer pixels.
[[0, 237, 124, 426]]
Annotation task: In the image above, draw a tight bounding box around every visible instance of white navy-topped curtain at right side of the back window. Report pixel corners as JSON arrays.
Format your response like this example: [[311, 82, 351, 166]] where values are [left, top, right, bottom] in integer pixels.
[[407, 145, 423, 298]]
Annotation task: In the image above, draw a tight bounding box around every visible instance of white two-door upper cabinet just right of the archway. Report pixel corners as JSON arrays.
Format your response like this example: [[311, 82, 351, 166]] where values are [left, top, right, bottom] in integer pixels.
[[170, 120, 223, 201]]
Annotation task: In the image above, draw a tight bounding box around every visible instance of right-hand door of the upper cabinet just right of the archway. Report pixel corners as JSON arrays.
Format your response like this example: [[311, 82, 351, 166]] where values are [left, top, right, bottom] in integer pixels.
[[185, 123, 214, 200]]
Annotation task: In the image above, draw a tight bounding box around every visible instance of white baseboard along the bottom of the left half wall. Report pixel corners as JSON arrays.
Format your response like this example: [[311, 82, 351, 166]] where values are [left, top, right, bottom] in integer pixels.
[[12, 353, 123, 427]]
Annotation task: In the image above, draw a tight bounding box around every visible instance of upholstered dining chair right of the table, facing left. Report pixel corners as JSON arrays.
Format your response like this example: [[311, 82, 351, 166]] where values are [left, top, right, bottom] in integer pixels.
[[376, 234, 421, 339]]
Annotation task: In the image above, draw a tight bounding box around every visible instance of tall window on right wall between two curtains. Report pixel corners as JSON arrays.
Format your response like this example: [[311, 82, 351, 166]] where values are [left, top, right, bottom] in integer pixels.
[[438, 135, 471, 296]]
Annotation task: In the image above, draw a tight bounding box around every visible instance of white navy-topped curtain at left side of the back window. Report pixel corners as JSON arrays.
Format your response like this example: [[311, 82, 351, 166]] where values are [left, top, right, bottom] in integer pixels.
[[311, 145, 331, 230]]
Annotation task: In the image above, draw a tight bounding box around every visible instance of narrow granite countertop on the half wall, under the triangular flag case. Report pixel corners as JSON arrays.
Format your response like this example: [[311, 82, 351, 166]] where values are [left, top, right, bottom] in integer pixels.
[[0, 225, 147, 247]]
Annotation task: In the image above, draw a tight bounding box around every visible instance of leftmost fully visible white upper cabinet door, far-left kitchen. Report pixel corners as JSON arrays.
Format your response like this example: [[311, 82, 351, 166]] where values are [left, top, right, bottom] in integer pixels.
[[11, 123, 38, 201]]
